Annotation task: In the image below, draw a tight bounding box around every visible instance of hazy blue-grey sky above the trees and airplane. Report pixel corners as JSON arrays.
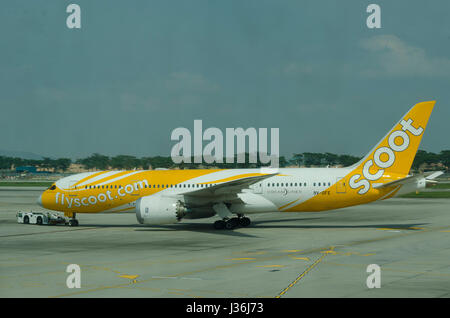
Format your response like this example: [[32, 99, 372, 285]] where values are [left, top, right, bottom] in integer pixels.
[[0, 0, 450, 158]]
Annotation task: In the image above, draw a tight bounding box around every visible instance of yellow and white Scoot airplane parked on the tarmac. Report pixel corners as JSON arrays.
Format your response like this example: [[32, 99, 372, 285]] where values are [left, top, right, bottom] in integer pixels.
[[38, 101, 441, 229]]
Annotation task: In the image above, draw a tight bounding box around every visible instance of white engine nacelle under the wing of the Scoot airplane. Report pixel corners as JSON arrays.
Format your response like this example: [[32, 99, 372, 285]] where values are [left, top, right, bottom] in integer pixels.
[[136, 195, 187, 225]]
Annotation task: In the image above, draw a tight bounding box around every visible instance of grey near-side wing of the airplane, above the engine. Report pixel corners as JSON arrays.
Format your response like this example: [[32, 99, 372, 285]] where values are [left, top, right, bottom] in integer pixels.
[[183, 173, 278, 197]]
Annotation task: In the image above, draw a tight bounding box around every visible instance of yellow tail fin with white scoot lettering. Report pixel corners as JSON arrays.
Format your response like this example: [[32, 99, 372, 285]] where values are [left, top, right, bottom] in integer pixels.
[[349, 101, 436, 194]]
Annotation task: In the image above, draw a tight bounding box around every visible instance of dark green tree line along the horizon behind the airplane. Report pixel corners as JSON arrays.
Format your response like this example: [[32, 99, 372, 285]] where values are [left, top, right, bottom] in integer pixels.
[[0, 150, 450, 172]]
